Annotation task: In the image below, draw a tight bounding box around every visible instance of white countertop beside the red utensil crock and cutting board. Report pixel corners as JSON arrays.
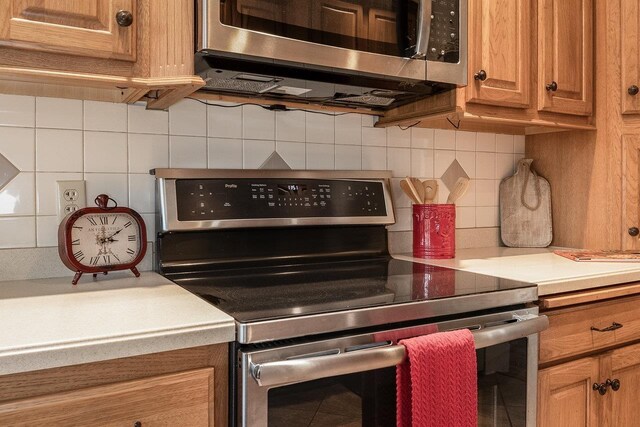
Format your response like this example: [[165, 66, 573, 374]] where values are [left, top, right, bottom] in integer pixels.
[[394, 247, 640, 296]]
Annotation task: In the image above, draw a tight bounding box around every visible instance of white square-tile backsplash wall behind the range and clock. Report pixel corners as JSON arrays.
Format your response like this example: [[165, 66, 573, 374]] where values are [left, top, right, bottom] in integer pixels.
[[0, 95, 524, 267]]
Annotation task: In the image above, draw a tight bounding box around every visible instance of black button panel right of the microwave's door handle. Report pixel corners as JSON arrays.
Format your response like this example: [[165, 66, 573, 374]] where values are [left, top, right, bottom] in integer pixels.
[[426, 0, 460, 64]]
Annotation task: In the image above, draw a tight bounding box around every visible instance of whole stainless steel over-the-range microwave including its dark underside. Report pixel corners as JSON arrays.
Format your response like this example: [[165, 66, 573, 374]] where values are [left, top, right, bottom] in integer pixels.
[[196, 0, 467, 109]]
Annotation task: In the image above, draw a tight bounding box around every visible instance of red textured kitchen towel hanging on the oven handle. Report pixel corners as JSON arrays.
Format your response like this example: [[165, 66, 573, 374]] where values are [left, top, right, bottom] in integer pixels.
[[396, 329, 478, 427]]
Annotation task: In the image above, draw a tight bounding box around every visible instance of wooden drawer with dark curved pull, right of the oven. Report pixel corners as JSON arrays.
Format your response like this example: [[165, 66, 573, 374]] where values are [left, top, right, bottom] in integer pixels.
[[540, 297, 640, 363]]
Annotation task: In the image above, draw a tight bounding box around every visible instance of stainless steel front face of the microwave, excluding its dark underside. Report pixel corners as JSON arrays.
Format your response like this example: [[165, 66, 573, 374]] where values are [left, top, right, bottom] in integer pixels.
[[198, 0, 467, 84]]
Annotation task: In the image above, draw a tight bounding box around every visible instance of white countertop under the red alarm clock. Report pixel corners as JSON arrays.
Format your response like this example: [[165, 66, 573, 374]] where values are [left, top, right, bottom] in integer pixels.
[[0, 272, 235, 375]]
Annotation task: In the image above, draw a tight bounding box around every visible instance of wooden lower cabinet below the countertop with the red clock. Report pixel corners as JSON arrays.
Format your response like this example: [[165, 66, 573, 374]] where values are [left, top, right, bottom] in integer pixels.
[[0, 344, 228, 427]]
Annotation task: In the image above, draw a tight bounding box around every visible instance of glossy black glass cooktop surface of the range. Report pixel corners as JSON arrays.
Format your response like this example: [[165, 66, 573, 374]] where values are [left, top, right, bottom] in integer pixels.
[[167, 257, 535, 323]]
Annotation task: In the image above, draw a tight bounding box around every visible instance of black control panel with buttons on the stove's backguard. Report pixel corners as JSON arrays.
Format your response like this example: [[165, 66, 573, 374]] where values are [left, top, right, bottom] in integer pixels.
[[176, 178, 390, 221]]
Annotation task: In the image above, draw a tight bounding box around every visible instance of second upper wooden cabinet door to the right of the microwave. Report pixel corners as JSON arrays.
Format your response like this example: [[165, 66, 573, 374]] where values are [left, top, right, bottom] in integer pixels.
[[537, 0, 593, 116]]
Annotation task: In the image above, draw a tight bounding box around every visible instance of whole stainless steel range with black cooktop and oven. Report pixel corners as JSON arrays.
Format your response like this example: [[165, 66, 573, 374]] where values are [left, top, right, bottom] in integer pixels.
[[153, 169, 548, 427]]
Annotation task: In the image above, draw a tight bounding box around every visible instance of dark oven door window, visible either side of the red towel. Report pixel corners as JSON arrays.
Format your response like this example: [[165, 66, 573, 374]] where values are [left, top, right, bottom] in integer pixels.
[[268, 339, 535, 427]]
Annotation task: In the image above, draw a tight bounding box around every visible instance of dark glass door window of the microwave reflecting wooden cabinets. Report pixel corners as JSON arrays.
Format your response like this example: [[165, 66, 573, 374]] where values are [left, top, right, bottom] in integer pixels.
[[220, 0, 418, 57]]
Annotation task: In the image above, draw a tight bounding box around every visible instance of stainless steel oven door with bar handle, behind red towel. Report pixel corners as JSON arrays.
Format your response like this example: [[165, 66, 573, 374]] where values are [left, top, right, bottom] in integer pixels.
[[237, 308, 548, 427]]
